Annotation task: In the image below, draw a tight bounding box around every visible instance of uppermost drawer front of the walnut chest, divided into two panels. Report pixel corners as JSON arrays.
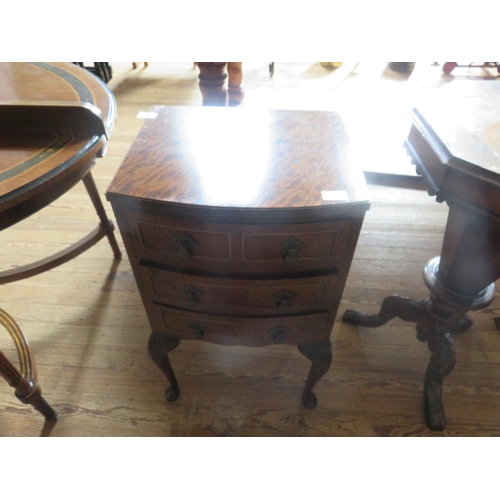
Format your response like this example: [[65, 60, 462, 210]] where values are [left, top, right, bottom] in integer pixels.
[[127, 212, 350, 273]]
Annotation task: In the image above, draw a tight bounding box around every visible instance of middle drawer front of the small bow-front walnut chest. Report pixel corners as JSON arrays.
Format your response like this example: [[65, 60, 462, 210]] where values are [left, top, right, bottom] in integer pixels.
[[140, 268, 340, 315]]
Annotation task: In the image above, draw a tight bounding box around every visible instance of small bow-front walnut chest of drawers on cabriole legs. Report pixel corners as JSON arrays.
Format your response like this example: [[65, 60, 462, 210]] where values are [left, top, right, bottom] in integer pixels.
[[107, 107, 369, 408]]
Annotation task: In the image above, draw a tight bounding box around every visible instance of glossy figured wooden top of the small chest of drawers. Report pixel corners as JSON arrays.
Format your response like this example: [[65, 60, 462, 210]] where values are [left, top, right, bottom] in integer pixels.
[[108, 106, 368, 215]]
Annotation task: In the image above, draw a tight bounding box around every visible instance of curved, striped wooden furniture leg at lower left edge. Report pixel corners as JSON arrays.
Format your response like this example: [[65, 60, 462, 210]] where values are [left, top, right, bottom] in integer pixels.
[[0, 309, 57, 421]]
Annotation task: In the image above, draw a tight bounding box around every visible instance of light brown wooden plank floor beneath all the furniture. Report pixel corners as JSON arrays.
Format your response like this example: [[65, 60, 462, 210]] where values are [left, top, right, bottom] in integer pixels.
[[0, 62, 500, 436]]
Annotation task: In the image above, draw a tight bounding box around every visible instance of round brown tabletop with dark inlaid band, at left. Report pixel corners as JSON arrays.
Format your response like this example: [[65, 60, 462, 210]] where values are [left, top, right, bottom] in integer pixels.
[[0, 63, 116, 202]]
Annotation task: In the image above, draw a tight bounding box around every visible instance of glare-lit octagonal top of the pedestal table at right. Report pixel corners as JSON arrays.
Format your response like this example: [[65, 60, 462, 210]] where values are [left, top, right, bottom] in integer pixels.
[[406, 81, 500, 222]]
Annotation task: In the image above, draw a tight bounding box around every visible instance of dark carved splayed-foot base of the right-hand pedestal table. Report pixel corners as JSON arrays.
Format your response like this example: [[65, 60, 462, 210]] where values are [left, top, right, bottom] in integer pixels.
[[342, 258, 495, 431]]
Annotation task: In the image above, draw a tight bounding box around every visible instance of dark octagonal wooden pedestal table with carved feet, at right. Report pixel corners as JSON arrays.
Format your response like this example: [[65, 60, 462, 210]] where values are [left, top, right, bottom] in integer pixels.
[[343, 81, 500, 430]]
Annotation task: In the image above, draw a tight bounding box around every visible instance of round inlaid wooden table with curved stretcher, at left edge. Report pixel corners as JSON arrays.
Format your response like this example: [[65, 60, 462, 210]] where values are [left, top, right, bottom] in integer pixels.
[[0, 63, 121, 420]]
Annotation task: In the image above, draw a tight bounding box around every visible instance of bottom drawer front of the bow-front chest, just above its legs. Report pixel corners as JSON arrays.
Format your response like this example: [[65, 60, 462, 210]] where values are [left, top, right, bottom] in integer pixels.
[[151, 305, 333, 346]]
